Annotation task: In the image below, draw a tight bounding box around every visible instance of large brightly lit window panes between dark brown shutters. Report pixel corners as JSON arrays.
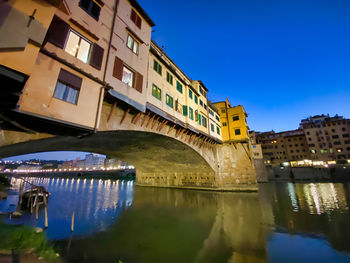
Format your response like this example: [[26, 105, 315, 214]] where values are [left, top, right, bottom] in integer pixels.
[[64, 30, 91, 63]]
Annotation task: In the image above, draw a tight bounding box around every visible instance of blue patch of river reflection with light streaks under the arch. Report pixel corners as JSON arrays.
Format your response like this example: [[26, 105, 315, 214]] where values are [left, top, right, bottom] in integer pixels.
[[0, 177, 133, 239]]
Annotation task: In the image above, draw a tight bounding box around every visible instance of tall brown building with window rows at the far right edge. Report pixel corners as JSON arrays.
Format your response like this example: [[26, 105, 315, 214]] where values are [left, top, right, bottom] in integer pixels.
[[300, 115, 350, 162]]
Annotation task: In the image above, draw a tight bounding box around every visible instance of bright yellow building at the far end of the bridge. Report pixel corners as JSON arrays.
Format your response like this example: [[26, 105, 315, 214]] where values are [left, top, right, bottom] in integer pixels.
[[213, 99, 249, 142]]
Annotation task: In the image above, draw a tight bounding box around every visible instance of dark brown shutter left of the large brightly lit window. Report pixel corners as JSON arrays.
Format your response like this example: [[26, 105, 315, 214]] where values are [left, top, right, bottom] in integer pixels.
[[44, 16, 70, 49]]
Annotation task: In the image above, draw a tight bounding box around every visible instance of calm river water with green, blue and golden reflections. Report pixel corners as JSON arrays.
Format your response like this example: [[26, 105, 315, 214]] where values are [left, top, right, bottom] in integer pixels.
[[0, 178, 350, 263]]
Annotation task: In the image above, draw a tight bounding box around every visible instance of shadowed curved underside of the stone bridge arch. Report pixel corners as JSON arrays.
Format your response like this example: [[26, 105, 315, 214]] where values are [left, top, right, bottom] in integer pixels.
[[0, 131, 213, 174]]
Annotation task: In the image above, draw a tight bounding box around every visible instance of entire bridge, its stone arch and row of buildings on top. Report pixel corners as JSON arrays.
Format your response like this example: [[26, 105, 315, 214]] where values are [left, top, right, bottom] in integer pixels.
[[0, 0, 257, 191]]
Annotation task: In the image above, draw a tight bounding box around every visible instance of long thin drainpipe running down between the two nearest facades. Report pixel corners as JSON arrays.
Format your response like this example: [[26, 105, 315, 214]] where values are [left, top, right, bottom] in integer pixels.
[[94, 0, 119, 133]]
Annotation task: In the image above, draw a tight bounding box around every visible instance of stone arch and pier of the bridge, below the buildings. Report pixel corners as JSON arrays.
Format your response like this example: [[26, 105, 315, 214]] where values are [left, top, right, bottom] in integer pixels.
[[0, 102, 257, 191]]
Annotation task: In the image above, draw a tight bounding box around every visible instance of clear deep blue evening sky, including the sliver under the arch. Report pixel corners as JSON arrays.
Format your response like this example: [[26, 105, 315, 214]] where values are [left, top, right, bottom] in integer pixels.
[[2, 0, 350, 160]]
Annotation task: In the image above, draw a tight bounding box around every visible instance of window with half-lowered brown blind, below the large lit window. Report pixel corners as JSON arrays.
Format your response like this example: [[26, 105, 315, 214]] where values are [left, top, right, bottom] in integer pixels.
[[53, 69, 83, 104]]
